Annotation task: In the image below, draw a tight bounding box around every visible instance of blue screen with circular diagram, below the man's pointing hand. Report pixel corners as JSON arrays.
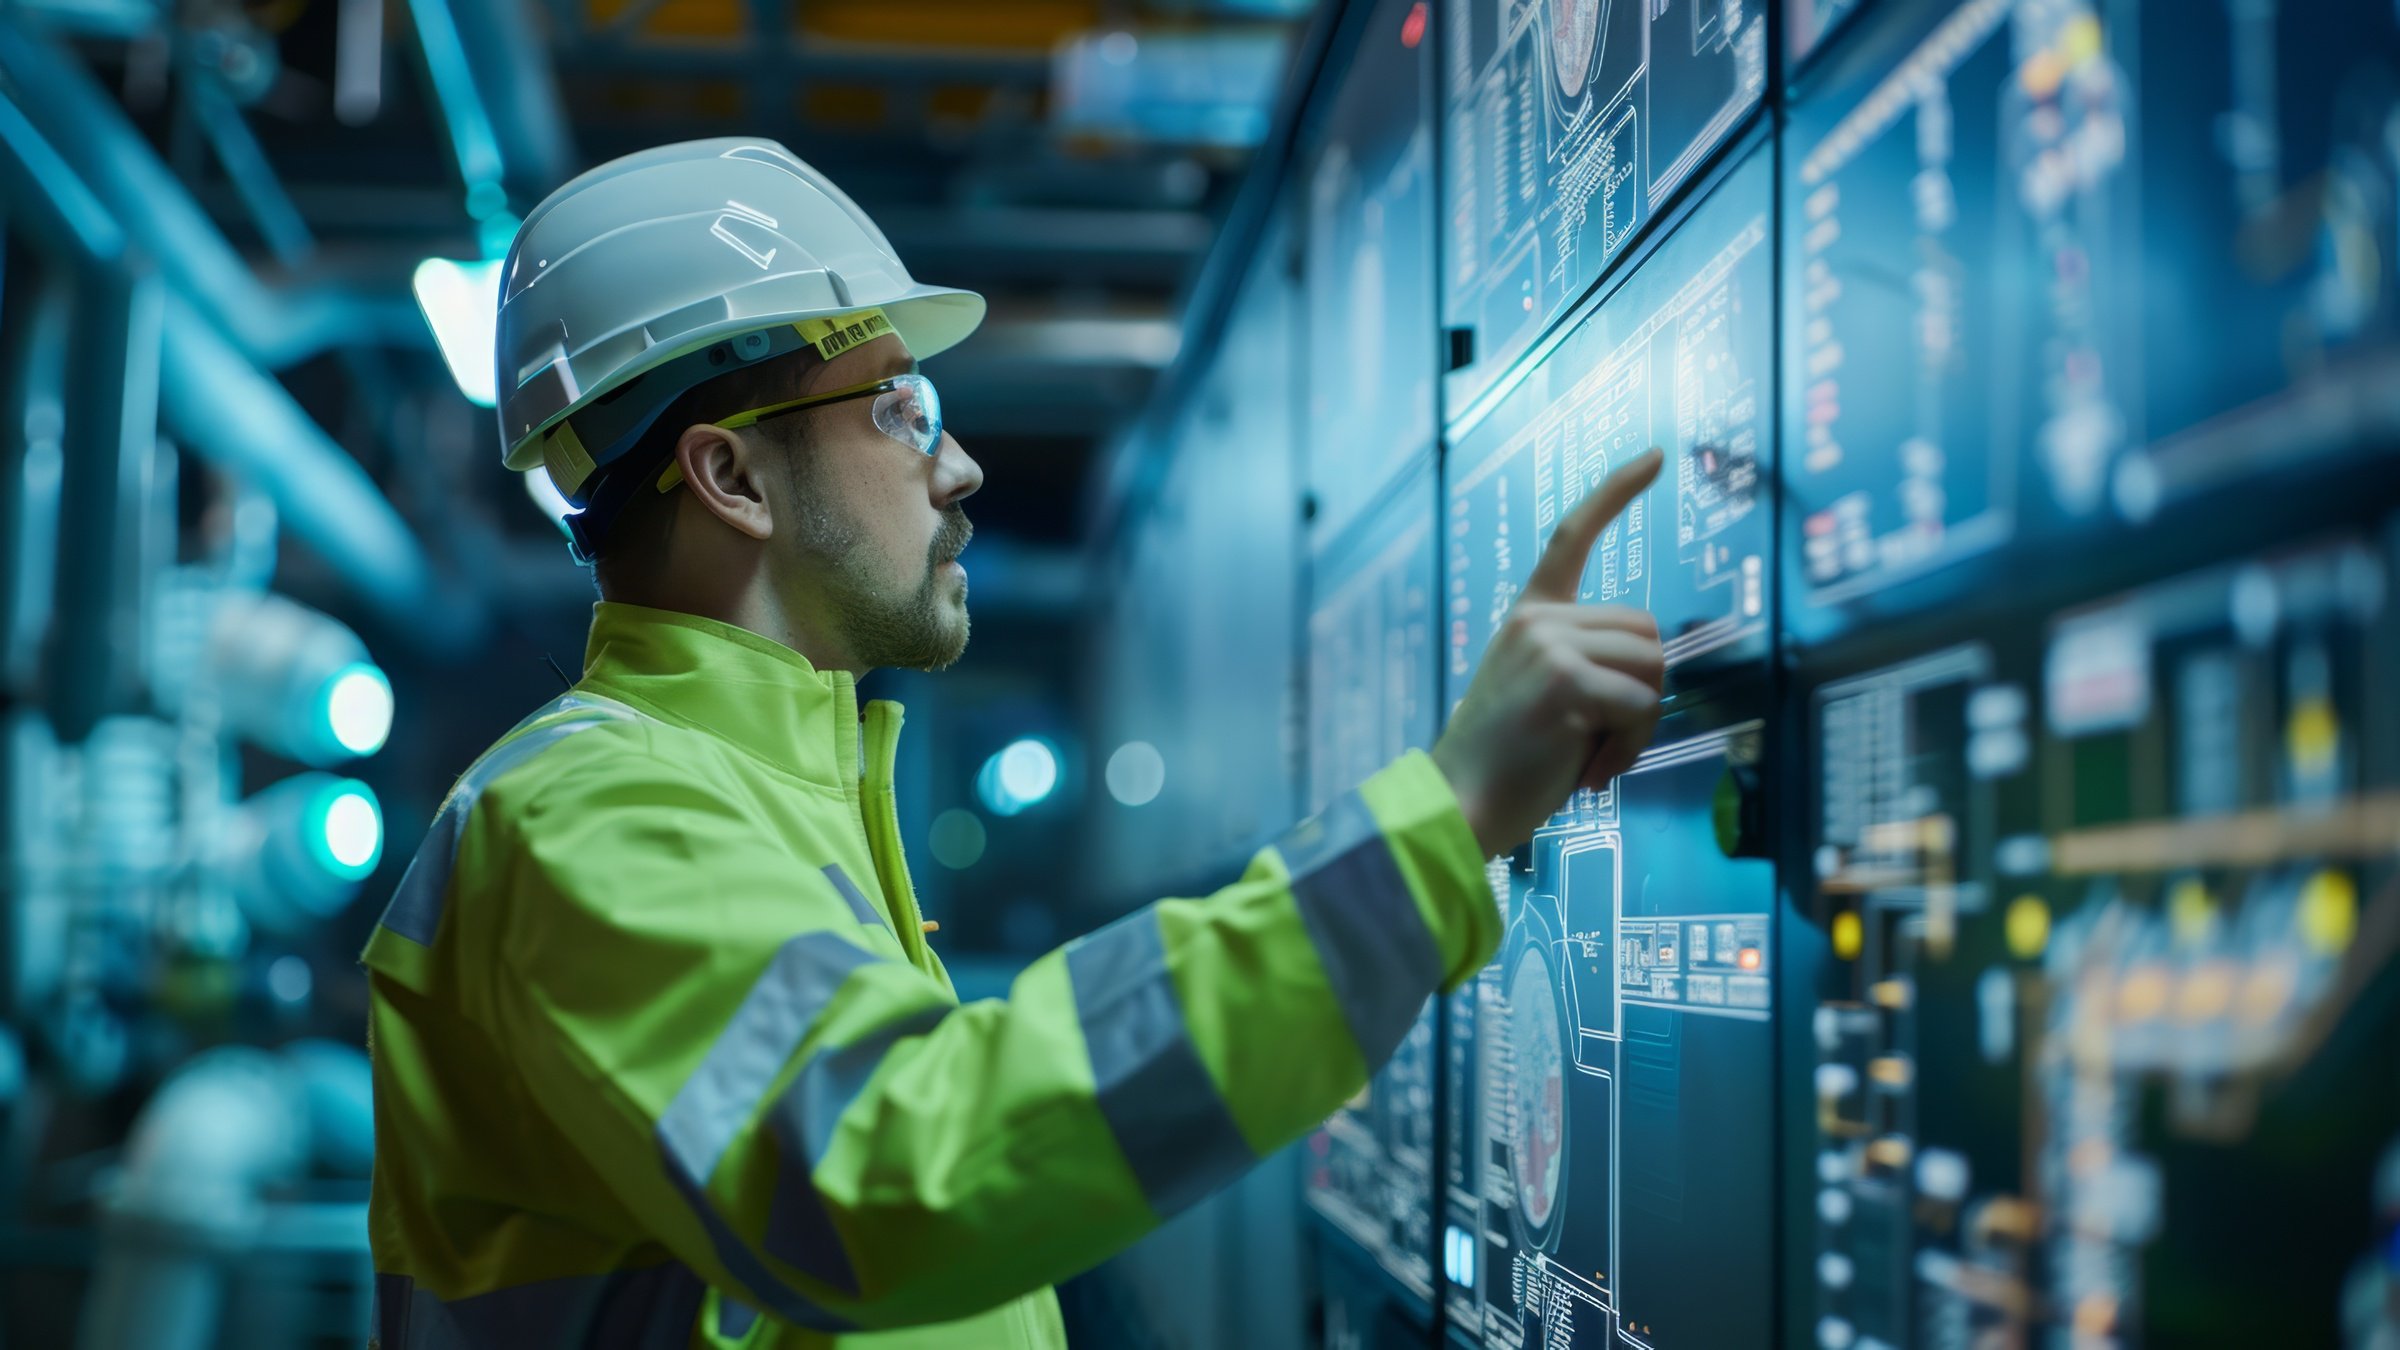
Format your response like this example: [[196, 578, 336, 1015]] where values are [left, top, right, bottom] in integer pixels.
[[1442, 723, 1774, 1350]]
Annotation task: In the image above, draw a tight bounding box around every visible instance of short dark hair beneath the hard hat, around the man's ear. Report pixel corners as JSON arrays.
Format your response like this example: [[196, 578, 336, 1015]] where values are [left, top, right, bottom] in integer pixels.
[[588, 346, 823, 598]]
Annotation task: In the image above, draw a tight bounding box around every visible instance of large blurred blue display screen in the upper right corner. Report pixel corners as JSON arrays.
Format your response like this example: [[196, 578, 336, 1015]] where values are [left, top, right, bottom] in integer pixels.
[[1781, 0, 2400, 641]]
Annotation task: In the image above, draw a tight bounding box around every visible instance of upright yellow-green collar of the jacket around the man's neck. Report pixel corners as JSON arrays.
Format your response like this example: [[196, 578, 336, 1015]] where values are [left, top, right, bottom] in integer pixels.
[[583, 601, 859, 793]]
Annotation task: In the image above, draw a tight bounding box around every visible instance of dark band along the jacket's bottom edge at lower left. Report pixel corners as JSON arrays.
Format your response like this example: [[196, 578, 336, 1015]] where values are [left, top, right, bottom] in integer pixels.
[[374, 1264, 708, 1350]]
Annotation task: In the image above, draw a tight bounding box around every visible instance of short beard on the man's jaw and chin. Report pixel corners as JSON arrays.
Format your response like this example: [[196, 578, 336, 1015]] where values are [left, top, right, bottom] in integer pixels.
[[802, 480, 974, 670]]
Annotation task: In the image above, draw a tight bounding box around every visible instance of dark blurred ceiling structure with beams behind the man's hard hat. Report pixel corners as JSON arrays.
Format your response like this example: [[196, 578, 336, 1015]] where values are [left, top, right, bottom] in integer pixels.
[[0, 0, 1306, 629]]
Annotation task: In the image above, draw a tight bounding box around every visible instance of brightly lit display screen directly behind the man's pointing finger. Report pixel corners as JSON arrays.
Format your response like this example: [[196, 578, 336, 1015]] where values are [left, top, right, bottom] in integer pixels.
[[1445, 145, 1774, 697]]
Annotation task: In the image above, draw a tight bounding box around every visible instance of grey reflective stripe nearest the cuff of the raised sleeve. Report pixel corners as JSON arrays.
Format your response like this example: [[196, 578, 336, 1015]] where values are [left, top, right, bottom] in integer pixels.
[[1274, 793, 1442, 1071]]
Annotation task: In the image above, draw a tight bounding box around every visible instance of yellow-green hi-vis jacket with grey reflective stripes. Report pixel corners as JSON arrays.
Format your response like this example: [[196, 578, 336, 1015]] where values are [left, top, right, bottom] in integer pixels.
[[365, 603, 1498, 1350]]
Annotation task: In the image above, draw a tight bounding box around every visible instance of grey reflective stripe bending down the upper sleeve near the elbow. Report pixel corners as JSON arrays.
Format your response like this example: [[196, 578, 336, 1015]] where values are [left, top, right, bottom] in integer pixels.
[[658, 932, 881, 1331]]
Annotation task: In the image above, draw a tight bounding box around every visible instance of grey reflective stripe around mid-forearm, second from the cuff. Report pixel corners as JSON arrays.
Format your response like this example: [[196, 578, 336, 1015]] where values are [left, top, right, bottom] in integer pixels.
[[1066, 908, 1258, 1218]]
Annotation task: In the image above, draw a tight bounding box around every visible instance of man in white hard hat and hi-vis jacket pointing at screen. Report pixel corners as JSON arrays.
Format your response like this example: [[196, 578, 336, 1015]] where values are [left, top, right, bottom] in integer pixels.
[[365, 139, 1661, 1350]]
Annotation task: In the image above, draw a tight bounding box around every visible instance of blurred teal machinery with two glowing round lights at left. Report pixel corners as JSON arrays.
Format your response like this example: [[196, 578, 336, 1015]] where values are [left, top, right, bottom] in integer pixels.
[[0, 446, 394, 1350]]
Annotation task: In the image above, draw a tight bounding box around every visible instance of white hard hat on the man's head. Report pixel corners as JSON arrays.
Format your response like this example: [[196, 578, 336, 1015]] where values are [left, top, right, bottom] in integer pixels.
[[494, 137, 984, 504]]
